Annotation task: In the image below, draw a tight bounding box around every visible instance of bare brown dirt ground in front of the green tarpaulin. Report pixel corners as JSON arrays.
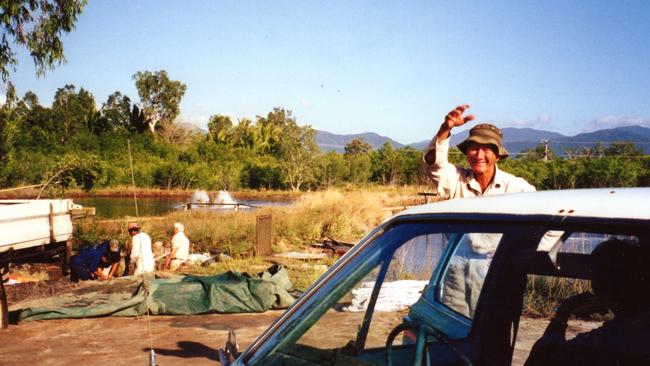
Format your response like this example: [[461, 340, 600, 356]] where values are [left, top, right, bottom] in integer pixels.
[[0, 311, 282, 366]]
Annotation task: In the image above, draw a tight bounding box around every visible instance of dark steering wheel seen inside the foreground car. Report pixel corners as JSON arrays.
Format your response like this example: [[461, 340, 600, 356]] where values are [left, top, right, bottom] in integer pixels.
[[386, 320, 473, 366]]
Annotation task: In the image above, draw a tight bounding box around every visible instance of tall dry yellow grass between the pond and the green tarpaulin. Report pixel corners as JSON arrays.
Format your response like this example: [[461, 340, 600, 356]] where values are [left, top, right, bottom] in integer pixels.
[[76, 187, 421, 290]]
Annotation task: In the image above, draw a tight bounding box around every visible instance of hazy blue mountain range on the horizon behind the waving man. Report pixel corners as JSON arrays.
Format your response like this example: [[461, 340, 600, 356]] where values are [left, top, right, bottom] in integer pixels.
[[316, 126, 650, 155]]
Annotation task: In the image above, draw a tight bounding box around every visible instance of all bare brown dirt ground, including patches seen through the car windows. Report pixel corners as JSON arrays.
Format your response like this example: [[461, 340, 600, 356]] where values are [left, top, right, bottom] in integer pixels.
[[0, 266, 600, 366]]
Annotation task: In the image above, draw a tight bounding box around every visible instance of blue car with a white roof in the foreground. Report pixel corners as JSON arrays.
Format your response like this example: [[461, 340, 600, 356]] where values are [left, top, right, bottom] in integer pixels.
[[220, 188, 650, 365]]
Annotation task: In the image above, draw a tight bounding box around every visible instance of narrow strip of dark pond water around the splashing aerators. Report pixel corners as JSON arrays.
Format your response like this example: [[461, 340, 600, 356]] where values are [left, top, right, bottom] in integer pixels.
[[74, 197, 290, 219]]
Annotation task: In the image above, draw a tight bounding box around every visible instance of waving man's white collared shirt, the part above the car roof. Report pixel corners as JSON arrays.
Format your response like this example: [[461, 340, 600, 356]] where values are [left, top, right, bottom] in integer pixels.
[[423, 137, 535, 198]]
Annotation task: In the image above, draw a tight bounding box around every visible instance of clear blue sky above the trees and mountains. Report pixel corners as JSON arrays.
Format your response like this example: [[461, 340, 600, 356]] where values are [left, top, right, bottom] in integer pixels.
[[7, 0, 650, 143]]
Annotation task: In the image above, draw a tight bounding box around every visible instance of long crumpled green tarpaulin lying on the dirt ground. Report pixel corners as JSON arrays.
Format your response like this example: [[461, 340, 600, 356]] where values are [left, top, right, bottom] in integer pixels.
[[10, 266, 294, 321]]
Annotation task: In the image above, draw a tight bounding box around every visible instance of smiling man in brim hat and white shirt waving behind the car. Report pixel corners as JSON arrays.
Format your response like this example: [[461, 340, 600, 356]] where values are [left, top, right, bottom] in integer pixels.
[[423, 104, 535, 318]]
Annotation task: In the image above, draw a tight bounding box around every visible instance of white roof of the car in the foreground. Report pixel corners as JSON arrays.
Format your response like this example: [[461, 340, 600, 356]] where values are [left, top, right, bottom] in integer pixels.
[[395, 188, 650, 220]]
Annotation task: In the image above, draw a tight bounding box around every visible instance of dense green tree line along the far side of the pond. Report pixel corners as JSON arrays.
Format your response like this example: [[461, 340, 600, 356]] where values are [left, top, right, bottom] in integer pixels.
[[0, 70, 650, 190]]
